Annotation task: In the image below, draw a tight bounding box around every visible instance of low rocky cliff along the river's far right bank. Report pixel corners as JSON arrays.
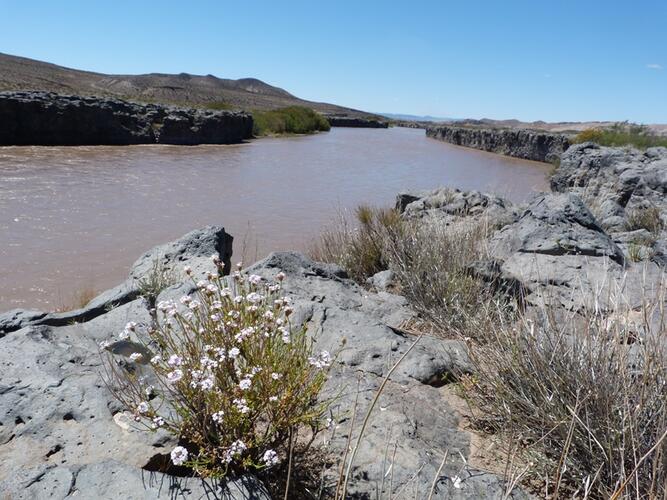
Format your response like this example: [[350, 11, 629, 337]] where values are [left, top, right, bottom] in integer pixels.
[[426, 125, 570, 162]]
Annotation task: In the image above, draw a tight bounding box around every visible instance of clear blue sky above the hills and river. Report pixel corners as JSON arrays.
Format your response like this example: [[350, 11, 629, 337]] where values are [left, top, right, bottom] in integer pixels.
[[0, 0, 667, 123]]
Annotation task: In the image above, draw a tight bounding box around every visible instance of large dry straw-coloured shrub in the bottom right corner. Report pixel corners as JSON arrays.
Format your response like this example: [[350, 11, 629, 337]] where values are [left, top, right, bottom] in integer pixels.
[[466, 300, 667, 499]]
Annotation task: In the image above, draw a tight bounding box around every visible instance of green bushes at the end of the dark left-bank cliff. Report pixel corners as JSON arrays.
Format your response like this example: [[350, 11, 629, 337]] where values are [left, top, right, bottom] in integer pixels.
[[252, 106, 331, 136]]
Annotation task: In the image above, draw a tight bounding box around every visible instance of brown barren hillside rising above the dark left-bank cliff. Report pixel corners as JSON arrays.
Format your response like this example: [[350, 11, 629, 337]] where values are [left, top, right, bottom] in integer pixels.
[[0, 53, 370, 116]]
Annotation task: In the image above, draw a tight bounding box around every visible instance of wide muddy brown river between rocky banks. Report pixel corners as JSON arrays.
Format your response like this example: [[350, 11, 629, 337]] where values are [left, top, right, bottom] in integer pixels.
[[0, 128, 549, 311]]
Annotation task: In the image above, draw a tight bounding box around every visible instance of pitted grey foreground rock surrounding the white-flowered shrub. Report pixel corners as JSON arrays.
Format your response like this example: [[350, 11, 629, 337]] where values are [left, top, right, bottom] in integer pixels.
[[0, 228, 527, 500]]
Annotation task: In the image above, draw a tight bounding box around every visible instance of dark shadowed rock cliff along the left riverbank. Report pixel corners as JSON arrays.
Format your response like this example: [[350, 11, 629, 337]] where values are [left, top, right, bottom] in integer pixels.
[[0, 92, 252, 146]]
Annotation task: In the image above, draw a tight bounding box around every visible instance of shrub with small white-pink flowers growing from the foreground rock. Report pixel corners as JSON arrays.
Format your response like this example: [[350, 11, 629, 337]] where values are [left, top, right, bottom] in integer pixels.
[[102, 261, 331, 477]]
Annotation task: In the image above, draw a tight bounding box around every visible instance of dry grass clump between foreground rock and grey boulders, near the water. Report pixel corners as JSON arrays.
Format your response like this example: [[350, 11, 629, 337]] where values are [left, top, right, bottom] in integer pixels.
[[311, 206, 508, 337]]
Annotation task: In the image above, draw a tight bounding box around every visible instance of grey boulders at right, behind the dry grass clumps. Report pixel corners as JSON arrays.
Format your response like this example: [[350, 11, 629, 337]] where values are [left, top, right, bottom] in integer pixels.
[[397, 189, 667, 316]]
